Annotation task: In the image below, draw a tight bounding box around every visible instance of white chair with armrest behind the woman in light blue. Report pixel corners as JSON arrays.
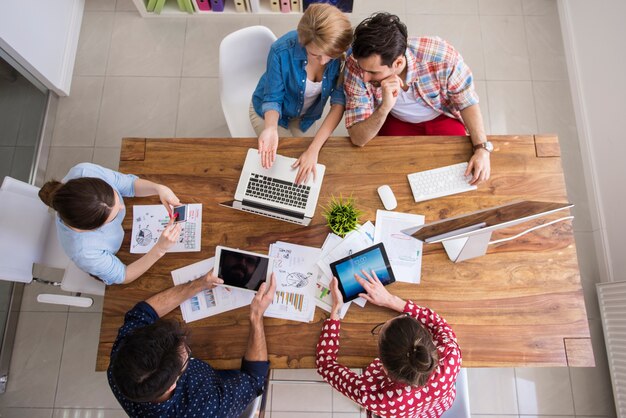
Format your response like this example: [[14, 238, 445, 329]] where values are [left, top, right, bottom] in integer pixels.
[[0, 176, 105, 308]]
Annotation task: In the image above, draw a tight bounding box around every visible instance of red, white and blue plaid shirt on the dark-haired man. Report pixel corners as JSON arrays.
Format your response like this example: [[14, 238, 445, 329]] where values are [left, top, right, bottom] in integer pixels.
[[343, 37, 478, 128]]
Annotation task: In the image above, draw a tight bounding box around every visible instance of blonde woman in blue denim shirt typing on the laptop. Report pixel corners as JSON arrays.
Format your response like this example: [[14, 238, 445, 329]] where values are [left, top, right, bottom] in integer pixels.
[[250, 4, 352, 183]]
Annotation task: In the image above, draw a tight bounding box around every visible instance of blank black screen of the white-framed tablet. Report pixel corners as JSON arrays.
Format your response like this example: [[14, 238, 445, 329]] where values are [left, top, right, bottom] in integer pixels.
[[217, 248, 269, 291]]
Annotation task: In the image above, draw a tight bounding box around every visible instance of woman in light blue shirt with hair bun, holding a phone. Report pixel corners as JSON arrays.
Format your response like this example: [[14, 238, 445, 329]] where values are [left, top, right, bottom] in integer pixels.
[[39, 163, 181, 284]]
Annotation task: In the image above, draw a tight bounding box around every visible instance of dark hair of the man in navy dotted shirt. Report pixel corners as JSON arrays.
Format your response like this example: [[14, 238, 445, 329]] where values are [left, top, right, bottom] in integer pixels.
[[111, 319, 187, 402]]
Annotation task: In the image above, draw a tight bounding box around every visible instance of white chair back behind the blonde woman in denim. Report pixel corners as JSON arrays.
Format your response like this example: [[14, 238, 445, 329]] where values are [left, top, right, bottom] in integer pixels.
[[219, 26, 276, 138]]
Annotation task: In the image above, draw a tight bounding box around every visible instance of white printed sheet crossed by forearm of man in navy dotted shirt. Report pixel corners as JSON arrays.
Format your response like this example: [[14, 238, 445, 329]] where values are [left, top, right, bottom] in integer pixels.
[[172, 257, 254, 323]]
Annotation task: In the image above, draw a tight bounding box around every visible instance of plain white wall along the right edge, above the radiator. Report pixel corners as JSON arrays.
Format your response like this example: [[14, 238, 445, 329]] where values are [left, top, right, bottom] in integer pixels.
[[559, 0, 626, 281]]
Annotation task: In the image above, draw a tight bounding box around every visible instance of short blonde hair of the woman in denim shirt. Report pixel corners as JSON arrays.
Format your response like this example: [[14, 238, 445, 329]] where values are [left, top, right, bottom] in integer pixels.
[[298, 3, 352, 58]]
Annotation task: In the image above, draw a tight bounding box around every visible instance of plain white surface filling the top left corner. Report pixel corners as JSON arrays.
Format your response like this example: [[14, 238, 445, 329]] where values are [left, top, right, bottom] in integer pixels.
[[0, 0, 85, 96]]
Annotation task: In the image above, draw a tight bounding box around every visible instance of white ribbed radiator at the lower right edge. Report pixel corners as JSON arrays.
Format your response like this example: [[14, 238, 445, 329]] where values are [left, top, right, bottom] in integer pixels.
[[597, 282, 626, 417]]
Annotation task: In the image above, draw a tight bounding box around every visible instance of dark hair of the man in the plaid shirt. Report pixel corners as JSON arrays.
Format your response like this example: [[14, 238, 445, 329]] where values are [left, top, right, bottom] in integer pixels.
[[352, 12, 408, 67]]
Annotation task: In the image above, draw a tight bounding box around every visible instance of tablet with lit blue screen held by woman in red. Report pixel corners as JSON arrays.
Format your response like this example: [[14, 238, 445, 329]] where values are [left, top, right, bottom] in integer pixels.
[[330, 242, 396, 302]]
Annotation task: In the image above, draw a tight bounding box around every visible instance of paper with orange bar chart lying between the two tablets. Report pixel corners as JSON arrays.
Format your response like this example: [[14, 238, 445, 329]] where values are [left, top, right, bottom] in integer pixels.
[[265, 241, 321, 322]]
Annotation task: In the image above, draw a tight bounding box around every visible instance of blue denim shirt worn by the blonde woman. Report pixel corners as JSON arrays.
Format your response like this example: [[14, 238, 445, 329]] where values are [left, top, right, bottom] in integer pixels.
[[252, 30, 346, 132]]
